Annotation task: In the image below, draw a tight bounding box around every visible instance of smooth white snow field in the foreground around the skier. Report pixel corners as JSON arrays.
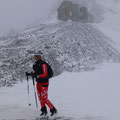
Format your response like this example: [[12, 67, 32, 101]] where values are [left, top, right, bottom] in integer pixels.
[[0, 64, 120, 120]]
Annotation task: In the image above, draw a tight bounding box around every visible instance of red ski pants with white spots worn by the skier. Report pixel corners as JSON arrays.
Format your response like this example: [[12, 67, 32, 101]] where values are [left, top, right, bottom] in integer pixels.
[[37, 83, 54, 109]]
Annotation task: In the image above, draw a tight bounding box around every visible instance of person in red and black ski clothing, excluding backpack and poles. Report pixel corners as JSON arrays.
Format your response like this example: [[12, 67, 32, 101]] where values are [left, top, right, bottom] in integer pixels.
[[26, 54, 57, 116]]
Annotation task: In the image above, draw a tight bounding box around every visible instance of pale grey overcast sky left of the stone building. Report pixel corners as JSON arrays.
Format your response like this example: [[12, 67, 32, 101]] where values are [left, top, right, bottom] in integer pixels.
[[0, 0, 60, 36]]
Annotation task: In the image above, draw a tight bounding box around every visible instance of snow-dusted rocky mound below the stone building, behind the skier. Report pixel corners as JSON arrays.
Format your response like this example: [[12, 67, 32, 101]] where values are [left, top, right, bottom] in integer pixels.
[[0, 22, 120, 86]]
